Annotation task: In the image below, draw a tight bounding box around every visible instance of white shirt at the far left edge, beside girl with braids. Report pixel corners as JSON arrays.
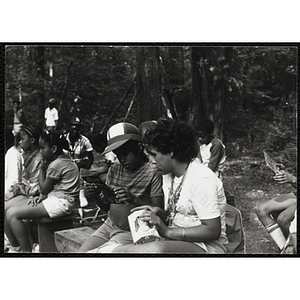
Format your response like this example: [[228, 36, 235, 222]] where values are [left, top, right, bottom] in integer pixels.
[[5, 146, 23, 193]]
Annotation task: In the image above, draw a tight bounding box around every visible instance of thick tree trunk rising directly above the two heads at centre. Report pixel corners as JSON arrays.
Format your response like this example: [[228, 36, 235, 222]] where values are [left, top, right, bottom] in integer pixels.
[[137, 47, 162, 123]]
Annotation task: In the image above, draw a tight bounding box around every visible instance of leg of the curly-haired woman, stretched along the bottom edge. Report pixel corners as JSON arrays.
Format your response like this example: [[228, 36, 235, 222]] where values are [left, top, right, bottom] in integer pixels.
[[113, 241, 205, 254]]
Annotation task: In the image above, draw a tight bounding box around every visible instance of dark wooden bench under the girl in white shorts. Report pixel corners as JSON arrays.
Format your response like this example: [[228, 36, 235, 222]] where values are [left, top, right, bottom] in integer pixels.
[[37, 213, 75, 253]]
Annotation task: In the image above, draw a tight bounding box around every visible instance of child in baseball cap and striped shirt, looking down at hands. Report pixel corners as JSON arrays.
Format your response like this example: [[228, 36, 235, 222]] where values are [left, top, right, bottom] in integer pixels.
[[78, 123, 164, 252]]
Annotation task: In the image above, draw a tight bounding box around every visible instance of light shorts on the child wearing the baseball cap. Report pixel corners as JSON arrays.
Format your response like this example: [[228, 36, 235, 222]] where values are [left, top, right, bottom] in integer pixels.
[[92, 217, 133, 245]]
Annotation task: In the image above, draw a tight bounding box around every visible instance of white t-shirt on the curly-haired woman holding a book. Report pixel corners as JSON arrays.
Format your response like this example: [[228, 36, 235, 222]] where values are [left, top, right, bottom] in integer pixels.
[[163, 158, 228, 244]]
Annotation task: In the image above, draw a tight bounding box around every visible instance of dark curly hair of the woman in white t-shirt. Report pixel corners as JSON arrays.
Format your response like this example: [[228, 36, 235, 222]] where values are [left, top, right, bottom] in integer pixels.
[[144, 118, 198, 162]]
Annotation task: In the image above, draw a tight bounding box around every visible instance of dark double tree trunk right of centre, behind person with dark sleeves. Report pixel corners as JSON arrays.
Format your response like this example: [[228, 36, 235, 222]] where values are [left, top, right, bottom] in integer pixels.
[[191, 47, 233, 139]]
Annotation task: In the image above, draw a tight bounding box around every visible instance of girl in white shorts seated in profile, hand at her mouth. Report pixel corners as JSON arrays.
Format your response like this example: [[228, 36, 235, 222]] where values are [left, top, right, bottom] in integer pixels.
[[5, 132, 80, 252]]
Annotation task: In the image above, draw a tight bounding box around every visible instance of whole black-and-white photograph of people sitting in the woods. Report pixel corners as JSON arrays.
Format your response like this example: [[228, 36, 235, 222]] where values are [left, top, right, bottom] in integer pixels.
[[3, 43, 298, 257]]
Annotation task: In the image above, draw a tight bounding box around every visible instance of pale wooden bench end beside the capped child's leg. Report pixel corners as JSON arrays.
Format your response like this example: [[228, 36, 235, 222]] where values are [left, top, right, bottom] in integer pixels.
[[54, 226, 95, 253]]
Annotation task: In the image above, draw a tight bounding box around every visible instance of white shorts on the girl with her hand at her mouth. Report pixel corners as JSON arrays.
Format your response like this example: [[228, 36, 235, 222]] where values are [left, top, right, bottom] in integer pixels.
[[42, 196, 74, 218]]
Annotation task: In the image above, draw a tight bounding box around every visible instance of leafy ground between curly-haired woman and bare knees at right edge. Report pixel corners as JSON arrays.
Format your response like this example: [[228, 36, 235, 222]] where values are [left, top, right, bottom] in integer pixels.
[[223, 157, 294, 254]]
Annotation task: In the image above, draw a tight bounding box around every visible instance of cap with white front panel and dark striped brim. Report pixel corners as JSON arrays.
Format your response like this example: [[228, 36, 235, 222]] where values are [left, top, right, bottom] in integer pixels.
[[101, 123, 141, 155]]
